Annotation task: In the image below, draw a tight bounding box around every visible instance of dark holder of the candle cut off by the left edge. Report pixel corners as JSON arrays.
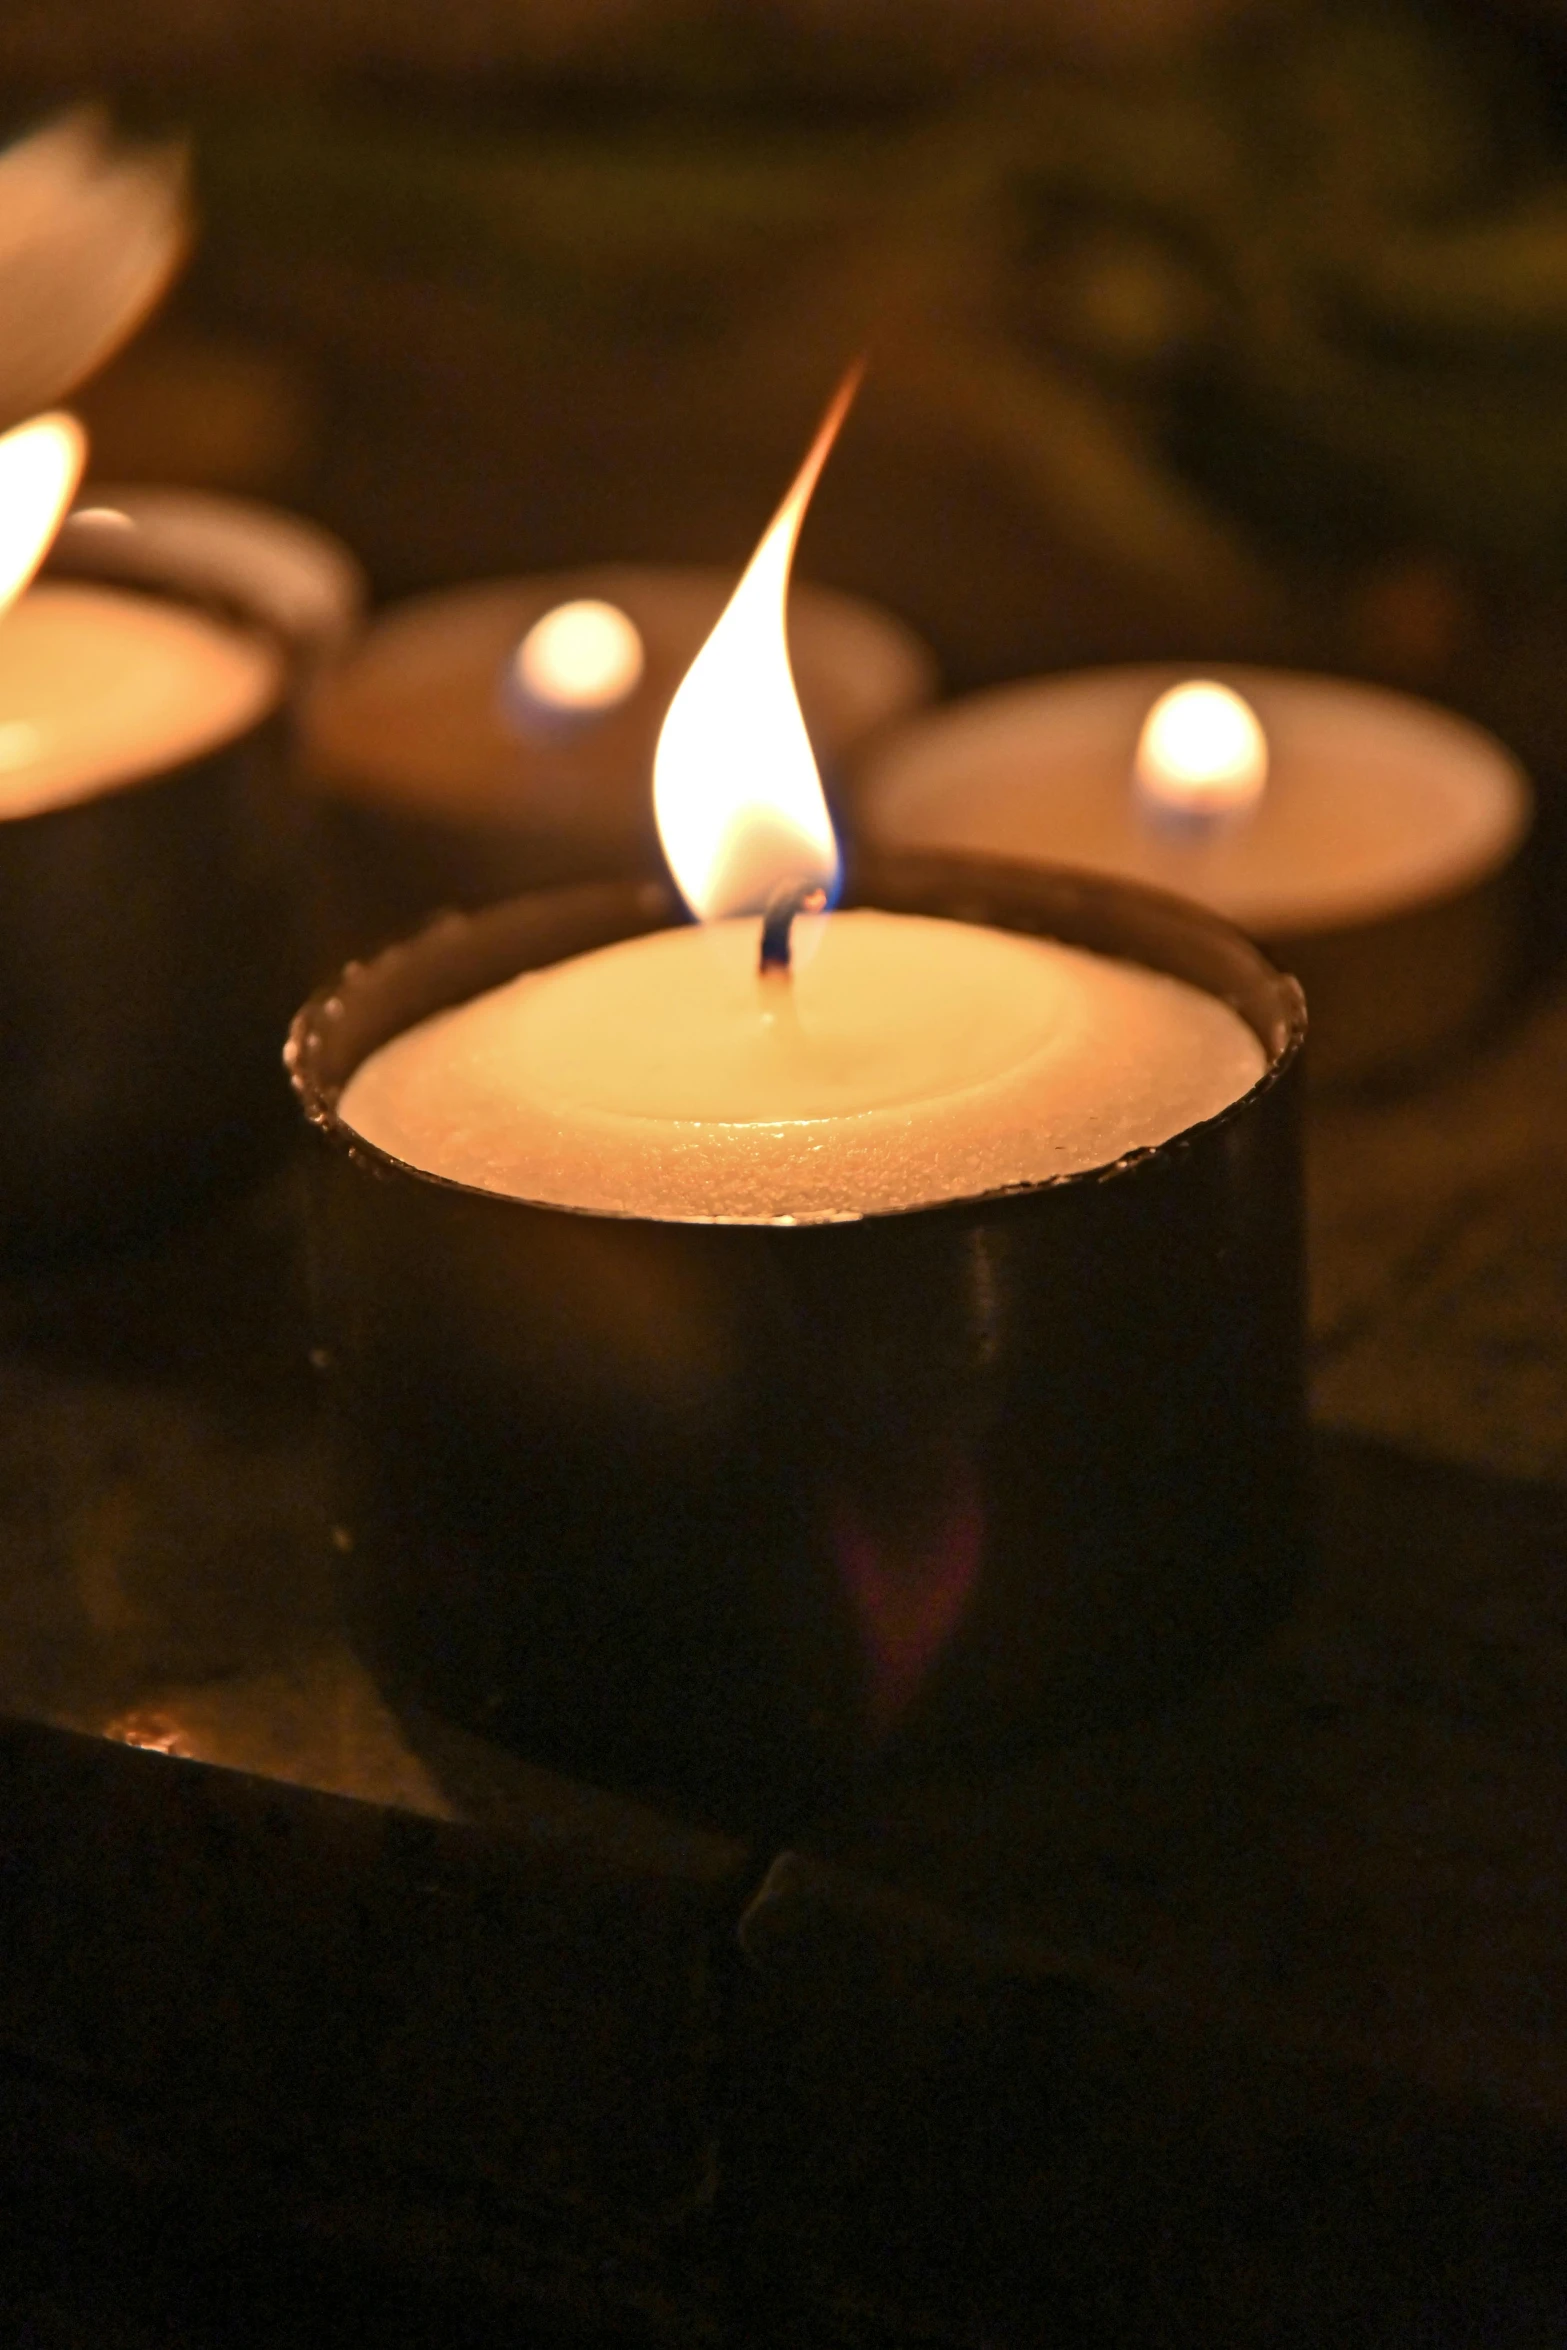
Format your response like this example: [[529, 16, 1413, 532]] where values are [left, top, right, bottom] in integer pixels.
[[0, 524, 314, 1257]]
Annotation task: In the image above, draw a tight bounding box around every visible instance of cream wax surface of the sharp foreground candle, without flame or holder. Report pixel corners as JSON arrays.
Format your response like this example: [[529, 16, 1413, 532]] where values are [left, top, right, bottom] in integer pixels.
[[341, 912, 1264, 1222]]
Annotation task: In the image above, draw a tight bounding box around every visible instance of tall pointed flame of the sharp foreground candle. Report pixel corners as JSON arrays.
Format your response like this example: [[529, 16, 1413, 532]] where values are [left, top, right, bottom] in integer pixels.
[[653, 364, 862, 921]]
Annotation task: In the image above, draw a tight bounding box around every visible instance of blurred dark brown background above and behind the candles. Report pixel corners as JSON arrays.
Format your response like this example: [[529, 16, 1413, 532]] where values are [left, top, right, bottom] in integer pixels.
[[15, 0, 1567, 768]]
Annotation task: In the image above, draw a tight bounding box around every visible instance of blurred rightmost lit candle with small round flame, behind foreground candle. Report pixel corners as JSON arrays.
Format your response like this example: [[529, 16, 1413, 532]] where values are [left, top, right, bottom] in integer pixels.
[[855, 667, 1532, 1074]]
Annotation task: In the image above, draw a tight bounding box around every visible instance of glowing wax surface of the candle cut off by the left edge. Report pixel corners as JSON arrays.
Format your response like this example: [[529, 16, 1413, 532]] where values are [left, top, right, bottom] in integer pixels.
[[0, 580, 282, 818]]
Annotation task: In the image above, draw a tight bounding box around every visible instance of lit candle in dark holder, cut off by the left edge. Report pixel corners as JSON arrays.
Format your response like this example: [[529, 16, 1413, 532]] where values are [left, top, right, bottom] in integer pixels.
[[0, 416, 296, 1253]]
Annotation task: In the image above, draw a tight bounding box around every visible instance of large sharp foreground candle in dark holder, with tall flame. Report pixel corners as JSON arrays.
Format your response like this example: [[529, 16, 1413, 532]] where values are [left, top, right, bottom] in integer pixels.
[[291, 366, 1299, 1826]]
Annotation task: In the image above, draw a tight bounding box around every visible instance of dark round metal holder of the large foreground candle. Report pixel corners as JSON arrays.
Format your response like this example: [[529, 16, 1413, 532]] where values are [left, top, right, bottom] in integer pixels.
[[289, 858, 1304, 1831]]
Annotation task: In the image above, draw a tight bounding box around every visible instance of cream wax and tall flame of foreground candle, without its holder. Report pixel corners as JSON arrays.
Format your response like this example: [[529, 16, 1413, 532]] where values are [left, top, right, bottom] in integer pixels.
[[343, 385, 1264, 1222]]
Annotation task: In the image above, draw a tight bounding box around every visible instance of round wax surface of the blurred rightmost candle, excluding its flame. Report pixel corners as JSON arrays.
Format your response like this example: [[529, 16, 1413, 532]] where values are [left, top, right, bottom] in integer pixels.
[[855, 667, 1532, 938]]
